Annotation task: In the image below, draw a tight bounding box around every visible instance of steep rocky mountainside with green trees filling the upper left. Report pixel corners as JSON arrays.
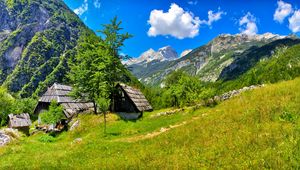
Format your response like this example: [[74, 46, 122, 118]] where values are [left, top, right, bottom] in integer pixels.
[[0, 0, 93, 97]]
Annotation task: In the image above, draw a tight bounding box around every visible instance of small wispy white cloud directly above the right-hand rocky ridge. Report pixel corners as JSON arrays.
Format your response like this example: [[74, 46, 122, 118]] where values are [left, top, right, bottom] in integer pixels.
[[239, 12, 258, 35]]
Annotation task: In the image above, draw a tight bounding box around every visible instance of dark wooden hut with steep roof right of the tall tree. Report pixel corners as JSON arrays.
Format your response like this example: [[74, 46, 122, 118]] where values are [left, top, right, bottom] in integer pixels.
[[114, 84, 153, 119]]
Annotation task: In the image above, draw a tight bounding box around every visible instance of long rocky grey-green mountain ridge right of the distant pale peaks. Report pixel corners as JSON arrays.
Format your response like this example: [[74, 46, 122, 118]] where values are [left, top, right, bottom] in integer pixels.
[[129, 33, 299, 85]]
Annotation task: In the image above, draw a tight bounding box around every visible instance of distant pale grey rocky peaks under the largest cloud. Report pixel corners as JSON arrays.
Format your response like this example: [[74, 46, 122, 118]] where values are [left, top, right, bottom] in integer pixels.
[[125, 46, 178, 65]]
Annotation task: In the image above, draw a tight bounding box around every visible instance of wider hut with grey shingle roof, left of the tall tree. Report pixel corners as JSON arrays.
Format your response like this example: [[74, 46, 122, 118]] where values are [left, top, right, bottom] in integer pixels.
[[34, 83, 94, 119]]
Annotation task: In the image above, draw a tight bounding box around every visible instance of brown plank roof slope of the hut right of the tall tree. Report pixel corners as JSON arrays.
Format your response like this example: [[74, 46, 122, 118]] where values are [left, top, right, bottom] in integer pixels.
[[119, 84, 153, 112]]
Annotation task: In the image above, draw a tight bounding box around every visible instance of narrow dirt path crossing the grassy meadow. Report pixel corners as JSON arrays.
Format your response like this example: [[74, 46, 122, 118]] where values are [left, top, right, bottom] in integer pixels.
[[115, 117, 200, 142]]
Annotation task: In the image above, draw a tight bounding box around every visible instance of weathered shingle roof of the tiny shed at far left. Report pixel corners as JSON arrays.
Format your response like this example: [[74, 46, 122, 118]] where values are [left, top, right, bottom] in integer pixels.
[[8, 113, 31, 128]]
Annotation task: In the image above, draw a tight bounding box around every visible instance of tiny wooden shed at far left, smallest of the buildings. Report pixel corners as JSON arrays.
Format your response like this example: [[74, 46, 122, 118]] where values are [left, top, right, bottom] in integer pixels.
[[8, 113, 31, 135]]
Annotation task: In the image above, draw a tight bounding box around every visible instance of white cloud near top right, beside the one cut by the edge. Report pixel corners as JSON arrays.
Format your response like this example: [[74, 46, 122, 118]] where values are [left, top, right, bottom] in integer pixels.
[[273, 0, 293, 23]]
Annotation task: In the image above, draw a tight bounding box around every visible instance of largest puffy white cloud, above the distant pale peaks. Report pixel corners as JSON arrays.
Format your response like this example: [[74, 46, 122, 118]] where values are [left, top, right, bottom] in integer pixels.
[[148, 3, 201, 39]]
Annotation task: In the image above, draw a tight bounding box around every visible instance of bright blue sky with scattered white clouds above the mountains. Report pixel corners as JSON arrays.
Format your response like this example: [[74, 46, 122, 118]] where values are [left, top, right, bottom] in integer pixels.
[[64, 0, 300, 57]]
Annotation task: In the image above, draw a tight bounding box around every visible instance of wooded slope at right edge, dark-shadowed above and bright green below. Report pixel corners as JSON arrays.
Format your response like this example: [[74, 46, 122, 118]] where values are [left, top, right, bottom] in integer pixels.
[[218, 42, 300, 94]]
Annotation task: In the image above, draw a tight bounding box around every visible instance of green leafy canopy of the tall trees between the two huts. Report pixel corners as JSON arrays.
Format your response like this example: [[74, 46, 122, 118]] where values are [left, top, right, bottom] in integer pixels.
[[69, 17, 131, 112]]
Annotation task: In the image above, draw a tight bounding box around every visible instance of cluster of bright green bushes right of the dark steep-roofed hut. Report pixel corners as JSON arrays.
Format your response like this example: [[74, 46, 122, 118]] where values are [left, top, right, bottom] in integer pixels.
[[145, 71, 216, 109]]
